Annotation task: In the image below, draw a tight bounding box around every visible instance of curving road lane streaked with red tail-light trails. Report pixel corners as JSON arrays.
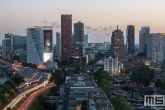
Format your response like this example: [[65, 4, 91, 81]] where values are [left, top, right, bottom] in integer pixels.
[[18, 85, 54, 110]]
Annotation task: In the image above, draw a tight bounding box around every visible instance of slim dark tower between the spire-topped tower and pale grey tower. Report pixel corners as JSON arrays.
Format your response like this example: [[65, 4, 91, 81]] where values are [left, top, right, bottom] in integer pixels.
[[126, 25, 135, 55]]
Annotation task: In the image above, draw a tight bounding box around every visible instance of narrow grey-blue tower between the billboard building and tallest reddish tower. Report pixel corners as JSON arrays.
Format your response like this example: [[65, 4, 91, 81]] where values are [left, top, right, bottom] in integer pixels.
[[56, 32, 61, 57]]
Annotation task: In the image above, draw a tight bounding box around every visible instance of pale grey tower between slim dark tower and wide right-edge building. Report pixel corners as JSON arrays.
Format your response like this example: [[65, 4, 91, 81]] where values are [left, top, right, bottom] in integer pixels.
[[139, 26, 150, 54]]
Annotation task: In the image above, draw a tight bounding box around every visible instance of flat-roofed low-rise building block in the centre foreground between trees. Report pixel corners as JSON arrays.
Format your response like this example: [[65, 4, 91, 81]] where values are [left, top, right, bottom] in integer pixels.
[[58, 73, 114, 110]]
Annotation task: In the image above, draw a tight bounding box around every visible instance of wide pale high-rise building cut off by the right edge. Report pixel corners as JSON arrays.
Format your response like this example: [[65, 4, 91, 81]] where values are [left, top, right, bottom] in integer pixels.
[[147, 33, 165, 62]]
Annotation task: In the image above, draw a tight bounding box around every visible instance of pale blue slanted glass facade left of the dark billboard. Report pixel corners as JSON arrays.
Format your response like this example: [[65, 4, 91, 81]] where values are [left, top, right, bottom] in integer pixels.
[[27, 27, 43, 64]]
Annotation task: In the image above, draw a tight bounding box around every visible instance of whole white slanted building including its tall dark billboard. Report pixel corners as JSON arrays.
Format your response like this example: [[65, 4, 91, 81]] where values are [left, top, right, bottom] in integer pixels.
[[27, 26, 53, 64]]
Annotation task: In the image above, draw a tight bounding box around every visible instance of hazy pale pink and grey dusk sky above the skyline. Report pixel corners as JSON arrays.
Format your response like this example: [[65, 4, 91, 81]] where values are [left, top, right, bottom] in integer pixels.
[[0, 0, 165, 44]]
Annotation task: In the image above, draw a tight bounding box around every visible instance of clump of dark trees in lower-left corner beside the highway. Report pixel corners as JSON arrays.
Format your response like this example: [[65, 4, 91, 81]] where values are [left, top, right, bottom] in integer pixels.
[[0, 74, 25, 107]]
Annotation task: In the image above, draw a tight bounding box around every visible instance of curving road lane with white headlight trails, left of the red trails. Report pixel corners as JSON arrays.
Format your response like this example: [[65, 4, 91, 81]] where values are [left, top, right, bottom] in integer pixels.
[[3, 74, 51, 110]]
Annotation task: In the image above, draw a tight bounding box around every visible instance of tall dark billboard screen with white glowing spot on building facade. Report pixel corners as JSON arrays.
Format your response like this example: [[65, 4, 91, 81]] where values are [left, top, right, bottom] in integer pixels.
[[44, 30, 53, 53]]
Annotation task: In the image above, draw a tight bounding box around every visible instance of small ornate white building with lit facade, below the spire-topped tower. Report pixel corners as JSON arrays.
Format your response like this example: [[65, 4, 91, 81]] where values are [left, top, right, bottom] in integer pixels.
[[104, 56, 118, 75]]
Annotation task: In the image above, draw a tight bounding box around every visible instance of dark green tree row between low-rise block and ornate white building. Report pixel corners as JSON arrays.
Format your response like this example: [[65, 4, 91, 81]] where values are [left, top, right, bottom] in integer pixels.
[[94, 69, 110, 97]]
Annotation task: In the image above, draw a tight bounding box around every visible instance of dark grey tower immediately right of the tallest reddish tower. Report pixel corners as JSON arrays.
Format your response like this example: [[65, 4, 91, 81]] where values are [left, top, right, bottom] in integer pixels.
[[74, 21, 84, 43]]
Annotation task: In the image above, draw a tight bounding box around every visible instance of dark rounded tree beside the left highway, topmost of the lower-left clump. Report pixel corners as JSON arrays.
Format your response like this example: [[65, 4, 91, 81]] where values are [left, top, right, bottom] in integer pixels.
[[11, 74, 25, 86]]
